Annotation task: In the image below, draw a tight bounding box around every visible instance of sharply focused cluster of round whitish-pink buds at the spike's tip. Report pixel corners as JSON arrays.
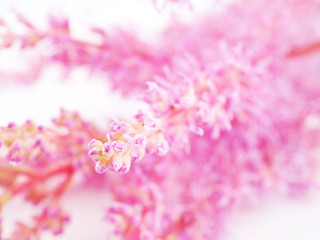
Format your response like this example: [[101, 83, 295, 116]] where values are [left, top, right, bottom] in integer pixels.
[[88, 112, 168, 174]]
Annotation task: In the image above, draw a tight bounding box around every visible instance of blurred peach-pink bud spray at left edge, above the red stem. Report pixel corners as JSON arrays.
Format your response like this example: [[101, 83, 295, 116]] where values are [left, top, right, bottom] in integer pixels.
[[0, 110, 100, 170]]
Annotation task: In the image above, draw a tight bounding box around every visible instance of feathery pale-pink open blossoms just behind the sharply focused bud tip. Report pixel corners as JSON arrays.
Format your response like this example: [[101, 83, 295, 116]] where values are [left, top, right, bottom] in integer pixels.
[[144, 46, 246, 143]]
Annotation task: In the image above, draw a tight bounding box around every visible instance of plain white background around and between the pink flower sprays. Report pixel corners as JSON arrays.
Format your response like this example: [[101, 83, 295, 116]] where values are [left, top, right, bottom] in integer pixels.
[[0, 0, 320, 240]]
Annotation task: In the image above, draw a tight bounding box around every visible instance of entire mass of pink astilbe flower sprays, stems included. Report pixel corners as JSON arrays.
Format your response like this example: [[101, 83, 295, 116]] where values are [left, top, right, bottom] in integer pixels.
[[0, 0, 320, 240]]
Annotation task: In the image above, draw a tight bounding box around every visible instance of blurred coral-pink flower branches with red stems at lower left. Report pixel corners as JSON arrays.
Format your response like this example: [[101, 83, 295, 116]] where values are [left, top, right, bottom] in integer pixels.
[[0, 110, 99, 240]]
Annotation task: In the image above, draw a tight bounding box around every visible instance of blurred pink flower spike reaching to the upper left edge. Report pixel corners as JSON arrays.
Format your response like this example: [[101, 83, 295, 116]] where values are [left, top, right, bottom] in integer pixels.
[[0, 14, 166, 92]]
